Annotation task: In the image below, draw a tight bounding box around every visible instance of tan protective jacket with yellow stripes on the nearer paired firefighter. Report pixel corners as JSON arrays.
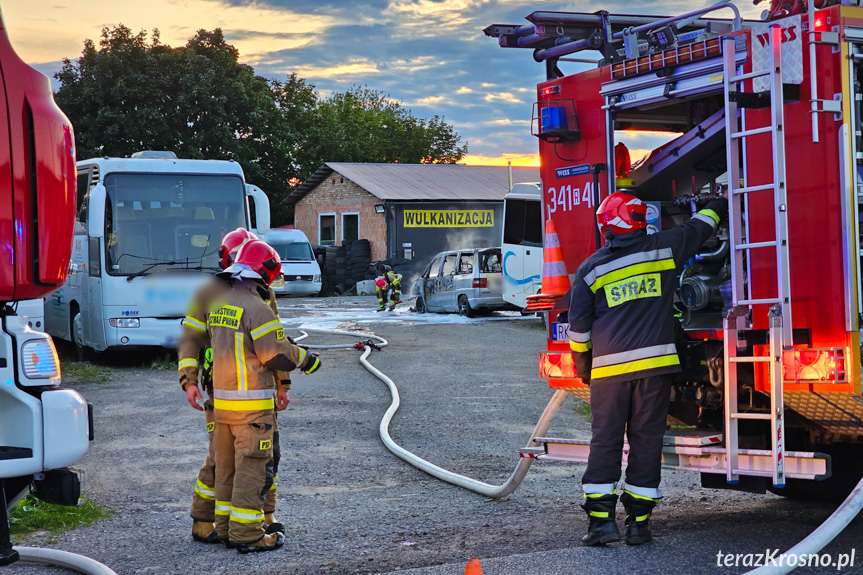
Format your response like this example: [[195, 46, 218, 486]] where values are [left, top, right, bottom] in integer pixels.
[[207, 279, 308, 425]]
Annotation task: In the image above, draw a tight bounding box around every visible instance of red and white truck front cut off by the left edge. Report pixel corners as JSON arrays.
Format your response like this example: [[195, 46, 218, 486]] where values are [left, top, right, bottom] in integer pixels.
[[0, 10, 92, 566]]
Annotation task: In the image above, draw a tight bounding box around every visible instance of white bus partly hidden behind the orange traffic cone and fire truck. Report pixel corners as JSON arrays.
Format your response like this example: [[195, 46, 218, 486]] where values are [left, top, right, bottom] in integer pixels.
[[501, 183, 542, 309]]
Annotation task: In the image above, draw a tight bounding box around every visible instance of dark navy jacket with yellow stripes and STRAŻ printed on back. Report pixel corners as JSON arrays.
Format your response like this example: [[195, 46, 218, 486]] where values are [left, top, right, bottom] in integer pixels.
[[569, 198, 728, 384]]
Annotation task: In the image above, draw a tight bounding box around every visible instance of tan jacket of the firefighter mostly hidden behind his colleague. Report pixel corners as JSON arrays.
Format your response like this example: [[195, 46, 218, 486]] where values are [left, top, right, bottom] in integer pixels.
[[178, 277, 291, 391]]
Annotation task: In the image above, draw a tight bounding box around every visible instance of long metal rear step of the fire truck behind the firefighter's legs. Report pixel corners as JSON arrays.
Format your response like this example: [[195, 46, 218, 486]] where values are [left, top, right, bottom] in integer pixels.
[[520, 431, 832, 480]]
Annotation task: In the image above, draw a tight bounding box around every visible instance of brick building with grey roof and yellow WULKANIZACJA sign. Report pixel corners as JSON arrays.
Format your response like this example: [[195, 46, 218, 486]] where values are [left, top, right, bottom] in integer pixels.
[[287, 162, 539, 267]]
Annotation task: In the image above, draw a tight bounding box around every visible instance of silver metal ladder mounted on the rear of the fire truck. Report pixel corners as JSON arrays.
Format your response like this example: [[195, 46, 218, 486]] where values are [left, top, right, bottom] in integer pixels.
[[723, 26, 792, 487]]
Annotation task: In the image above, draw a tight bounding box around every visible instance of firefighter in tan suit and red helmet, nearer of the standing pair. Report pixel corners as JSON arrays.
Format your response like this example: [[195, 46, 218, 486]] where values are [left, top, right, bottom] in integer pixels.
[[206, 240, 321, 553]]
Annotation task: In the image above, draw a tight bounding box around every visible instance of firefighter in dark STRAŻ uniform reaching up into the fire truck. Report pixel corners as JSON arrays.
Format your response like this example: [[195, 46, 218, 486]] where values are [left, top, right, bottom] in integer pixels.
[[569, 192, 728, 545]]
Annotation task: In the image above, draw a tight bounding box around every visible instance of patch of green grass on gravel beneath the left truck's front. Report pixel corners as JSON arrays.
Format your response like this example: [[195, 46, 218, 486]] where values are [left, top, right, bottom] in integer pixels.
[[9, 494, 111, 535]]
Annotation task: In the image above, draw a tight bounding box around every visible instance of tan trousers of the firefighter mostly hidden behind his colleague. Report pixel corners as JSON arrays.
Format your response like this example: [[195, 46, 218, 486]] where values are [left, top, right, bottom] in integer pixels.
[[190, 402, 281, 522]]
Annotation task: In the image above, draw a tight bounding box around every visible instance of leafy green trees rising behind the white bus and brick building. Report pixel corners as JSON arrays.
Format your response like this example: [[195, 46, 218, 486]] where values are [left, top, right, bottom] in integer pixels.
[[55, 25, 467, 226]]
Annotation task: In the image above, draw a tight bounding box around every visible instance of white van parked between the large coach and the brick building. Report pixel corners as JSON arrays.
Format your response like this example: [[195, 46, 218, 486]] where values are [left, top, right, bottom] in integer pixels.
[[262, 229, 321, 295]]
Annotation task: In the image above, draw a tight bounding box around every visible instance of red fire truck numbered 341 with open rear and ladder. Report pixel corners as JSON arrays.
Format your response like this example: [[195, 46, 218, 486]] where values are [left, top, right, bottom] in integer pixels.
[[485, 0, 863, 497]]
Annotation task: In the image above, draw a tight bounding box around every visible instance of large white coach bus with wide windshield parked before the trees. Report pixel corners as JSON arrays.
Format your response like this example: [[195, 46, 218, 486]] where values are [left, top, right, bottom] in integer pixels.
[[45, 152, 270, 356]]
